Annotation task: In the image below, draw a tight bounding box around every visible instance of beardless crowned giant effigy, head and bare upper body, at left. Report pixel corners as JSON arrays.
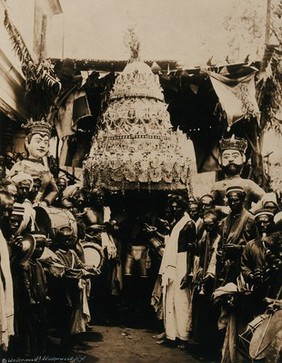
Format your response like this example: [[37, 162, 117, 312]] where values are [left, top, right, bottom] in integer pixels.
[[9, 120, 58, 205]]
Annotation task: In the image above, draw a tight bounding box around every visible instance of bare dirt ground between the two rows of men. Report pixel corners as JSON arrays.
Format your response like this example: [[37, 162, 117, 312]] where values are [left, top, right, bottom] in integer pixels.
[[69, 326, 202, 363]]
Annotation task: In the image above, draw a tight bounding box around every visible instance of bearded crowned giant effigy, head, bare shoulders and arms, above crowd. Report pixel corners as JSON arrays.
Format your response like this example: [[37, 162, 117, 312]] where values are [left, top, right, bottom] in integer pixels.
[[211, 135, 265, 210]]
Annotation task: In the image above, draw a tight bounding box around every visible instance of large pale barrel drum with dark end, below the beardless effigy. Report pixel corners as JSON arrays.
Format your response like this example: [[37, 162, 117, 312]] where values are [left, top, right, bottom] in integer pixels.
[[34, 206, 77, 239]]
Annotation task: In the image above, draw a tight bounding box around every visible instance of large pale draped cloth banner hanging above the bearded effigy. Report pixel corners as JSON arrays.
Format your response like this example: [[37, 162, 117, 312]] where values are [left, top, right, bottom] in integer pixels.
[[207, 72, 260, 127]]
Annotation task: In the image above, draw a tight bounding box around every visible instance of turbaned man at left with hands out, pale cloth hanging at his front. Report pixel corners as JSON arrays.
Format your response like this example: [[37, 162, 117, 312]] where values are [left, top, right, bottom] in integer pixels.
[[52, 226, 99, 349]]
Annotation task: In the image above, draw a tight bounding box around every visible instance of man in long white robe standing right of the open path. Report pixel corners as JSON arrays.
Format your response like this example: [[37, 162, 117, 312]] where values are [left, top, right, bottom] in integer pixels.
[[160, 195, 196, 349]]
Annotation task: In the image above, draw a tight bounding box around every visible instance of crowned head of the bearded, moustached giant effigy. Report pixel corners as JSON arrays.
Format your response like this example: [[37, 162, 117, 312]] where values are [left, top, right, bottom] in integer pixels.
[[219, 135, 248, 176]]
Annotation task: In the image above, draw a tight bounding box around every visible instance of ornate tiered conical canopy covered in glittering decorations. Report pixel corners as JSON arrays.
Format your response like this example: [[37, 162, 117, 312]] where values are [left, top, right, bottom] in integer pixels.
[[84, 58, 194, 191]]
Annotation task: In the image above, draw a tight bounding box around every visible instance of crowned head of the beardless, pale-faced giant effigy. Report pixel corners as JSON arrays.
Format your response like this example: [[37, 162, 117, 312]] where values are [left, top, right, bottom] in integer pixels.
[[23, 121, 51, 159]]
